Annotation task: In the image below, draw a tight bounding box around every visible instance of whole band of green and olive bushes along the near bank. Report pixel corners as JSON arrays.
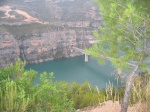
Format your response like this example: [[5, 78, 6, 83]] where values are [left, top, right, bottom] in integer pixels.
[[0, 60, 133, 112]]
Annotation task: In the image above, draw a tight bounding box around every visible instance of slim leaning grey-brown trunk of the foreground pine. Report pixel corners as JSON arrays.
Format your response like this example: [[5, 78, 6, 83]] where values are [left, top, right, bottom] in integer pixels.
[[121, 65, 139, 112]]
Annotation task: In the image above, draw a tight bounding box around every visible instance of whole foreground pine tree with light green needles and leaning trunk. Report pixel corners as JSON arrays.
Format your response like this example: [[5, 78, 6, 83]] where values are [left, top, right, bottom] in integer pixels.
[[88, 0, 150, 112]]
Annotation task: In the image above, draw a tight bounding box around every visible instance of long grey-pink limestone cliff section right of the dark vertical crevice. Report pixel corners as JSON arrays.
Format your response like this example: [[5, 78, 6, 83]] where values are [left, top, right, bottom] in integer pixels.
[[20, 30, 90, 63]]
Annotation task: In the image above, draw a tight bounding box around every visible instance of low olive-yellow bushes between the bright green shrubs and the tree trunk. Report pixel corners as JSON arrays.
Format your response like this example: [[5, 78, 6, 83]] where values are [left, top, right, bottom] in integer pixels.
[[56, 79, 124, 109]]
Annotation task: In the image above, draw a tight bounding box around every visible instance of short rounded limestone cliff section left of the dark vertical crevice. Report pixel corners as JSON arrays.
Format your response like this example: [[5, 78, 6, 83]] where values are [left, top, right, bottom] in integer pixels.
[[0, 33, 20, 67]]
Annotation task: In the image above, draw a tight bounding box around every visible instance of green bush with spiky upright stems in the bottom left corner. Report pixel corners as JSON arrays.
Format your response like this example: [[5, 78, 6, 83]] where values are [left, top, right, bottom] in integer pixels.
[[0, 79, 31, 112]]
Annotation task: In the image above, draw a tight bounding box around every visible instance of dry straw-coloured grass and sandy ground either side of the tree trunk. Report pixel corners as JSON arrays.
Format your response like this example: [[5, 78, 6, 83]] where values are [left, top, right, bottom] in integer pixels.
[[79, 73, 150, 112]]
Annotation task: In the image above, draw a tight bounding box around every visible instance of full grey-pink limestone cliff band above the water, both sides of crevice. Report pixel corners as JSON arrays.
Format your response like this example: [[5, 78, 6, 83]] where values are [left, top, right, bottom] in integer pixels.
[[0, 30, 92, 67]]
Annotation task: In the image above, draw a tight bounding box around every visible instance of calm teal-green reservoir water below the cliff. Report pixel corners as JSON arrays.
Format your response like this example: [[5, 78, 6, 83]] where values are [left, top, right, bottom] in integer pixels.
[[25, 56, 116, 88]]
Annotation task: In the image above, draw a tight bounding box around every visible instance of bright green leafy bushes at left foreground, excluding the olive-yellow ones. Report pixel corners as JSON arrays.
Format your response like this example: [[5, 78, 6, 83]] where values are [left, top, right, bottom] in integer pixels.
[[0, 60, 74, 112]]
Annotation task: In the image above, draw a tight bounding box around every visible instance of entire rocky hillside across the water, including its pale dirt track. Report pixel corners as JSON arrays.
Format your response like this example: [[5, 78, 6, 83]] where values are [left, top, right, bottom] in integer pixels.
[[0, 0, 102, 67]]
